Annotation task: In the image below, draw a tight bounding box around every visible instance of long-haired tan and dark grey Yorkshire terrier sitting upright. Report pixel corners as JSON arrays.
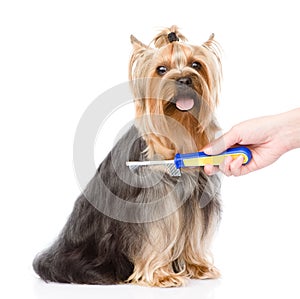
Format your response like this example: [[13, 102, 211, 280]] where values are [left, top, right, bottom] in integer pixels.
[[33, 26, 222, 287]]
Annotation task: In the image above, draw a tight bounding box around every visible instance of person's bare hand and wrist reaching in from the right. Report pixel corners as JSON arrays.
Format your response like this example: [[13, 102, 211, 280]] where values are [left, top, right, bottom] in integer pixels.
[[203, 109, 300, 176]]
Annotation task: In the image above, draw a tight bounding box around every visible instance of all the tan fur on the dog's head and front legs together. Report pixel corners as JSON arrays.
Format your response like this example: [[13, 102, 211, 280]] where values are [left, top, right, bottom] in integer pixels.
[[128, 26, 222, 287]]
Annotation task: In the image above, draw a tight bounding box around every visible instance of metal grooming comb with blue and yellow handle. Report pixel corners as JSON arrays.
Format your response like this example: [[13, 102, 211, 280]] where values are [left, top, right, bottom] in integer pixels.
[[126, 146, 252, 176]]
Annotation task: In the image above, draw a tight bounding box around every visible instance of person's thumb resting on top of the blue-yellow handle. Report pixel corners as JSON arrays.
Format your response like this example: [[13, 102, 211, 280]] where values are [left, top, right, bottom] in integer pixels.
[[202, 129, 238, 155]]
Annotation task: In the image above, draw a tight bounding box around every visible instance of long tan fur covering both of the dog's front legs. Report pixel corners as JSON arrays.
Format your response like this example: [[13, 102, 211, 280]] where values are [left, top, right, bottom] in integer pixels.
[[128, 179, 219, 287]]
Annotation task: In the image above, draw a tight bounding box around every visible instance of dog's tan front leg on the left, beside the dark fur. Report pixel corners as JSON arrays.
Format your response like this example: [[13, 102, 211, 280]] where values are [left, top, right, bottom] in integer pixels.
[[128, 211, 187, 287]]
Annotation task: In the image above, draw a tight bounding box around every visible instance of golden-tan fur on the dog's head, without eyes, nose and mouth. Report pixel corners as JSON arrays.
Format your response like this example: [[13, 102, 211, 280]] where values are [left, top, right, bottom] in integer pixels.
[[129, 27, 221, 159]]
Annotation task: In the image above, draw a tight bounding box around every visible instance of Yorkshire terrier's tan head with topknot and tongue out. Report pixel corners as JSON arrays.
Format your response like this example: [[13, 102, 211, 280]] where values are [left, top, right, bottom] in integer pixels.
[[129, 26, 221, 158]]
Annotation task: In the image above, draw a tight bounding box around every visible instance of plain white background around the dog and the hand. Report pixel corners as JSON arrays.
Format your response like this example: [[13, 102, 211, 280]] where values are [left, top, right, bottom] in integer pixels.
[[0, 0, 300, 299]]
